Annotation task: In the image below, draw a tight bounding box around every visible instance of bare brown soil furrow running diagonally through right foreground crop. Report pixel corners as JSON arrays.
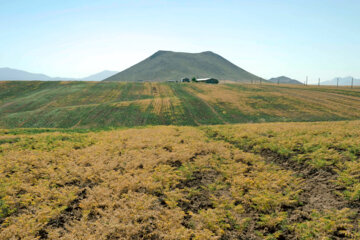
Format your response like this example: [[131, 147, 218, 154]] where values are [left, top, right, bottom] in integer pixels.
[[202, 124, 360, 237]]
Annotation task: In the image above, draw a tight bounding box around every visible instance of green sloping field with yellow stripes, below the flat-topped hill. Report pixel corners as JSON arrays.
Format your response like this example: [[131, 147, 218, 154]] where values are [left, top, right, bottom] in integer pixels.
[[0, 81, 360, 128]]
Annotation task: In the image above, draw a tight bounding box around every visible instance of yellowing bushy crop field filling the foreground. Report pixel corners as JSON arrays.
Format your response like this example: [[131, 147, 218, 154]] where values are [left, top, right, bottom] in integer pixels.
[[0, 121, 360, 239]]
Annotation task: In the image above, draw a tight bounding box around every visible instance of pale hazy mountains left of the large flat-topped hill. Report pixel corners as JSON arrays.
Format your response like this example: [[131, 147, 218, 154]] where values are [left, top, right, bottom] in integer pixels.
[[0, 68, 118, 81]]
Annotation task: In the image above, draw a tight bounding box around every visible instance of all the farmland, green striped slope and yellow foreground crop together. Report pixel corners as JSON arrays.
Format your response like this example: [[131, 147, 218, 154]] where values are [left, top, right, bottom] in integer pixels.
[[0, 81, 360, 239]]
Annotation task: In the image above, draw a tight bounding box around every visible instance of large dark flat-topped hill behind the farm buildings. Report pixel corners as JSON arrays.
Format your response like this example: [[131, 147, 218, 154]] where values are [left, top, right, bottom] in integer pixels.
[[104, 51, 261, 82]]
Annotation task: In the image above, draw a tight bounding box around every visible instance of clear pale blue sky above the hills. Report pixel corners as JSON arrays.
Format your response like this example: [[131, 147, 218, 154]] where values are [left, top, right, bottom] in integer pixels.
[[0, 0, 360, 83]]
